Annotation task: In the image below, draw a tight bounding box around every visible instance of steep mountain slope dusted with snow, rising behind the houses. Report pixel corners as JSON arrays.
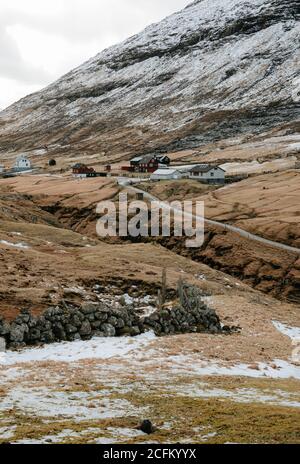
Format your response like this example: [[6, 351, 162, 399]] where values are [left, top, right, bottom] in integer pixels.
[[0, 0, 300, 160]]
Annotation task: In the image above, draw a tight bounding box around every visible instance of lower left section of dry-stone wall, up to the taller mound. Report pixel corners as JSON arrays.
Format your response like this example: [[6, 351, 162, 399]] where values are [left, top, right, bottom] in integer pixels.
[[0, 303, 144, 349]]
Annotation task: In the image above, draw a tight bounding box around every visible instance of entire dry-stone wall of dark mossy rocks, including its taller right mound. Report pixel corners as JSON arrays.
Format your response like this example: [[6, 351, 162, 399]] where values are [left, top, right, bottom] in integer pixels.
[[0, 282, 240, 349]]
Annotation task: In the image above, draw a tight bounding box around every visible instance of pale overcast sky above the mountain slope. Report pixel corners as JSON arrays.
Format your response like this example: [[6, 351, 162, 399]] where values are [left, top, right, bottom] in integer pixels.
[[0, 0, 191, 109]]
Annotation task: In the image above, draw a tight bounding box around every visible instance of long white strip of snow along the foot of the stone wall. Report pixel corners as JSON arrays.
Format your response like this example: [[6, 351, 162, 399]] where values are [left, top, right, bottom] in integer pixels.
[[0, 332, 300, 380]]
